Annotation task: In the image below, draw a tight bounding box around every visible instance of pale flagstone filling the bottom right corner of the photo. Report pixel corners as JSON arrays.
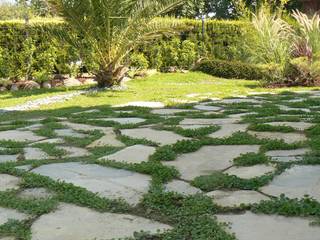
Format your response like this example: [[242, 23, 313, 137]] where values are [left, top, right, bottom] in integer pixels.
[[217, 212, 320, 240]]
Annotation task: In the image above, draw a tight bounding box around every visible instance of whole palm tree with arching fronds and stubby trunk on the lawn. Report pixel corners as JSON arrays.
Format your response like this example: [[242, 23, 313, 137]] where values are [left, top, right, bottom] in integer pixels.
[[50, 0, 184, 87]]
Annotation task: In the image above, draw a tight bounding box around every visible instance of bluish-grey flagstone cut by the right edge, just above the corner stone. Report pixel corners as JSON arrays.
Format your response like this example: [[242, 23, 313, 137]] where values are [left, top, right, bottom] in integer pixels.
[[261, 165, 320, 201]]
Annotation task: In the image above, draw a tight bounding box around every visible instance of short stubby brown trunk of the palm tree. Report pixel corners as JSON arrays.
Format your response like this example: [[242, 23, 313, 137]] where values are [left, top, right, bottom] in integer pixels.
[[96, 66, 128, 88]]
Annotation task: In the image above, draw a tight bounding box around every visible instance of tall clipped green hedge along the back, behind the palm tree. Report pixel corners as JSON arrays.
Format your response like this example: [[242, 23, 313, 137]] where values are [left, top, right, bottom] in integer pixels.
[[0, 19, 251, 81]]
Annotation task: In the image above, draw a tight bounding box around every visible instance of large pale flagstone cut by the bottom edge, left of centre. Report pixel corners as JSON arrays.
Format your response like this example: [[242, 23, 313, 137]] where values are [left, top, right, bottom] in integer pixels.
[[31, 204, 171, 240]]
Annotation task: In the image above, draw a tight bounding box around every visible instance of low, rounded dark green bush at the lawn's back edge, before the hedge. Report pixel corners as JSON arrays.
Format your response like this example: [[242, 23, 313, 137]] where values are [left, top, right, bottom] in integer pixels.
[[195, 59, 265, 80]]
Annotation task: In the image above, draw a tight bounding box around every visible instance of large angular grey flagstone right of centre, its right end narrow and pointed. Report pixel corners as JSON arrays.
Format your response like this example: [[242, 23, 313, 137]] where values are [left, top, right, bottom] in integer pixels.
[[164, 145, 260, 180]]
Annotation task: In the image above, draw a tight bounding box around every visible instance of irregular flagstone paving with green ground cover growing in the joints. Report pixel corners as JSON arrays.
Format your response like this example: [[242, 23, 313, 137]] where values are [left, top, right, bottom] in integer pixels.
[[0, 92, 320, 240]]
